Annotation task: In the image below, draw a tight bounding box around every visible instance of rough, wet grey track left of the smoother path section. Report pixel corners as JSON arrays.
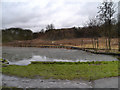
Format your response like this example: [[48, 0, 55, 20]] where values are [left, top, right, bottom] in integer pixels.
[[2, 75, 91, 88]]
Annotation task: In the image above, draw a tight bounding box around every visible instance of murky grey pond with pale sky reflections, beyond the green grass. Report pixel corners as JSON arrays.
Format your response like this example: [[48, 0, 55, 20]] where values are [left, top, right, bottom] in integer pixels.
[[2, 47, 117, 65]]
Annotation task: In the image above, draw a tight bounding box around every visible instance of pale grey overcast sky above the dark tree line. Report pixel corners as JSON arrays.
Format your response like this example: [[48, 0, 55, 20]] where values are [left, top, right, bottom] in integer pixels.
[[2, 0, 118, 32]]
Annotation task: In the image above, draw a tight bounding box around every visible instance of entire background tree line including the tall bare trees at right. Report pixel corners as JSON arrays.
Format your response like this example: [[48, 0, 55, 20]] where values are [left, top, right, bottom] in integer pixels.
[[2, 1, 120, 50]]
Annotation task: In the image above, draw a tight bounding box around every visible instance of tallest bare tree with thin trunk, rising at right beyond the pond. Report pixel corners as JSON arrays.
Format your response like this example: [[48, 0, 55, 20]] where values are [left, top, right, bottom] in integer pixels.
[[98, 0, 115, 50]]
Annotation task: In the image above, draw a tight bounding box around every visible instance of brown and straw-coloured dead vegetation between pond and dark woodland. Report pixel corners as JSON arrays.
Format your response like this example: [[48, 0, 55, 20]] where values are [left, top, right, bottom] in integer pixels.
[[3, 38, 118, 50]]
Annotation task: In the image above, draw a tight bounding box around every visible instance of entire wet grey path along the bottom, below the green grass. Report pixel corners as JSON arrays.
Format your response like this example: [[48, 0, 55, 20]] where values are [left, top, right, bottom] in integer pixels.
[[2, 75, 118, 88]]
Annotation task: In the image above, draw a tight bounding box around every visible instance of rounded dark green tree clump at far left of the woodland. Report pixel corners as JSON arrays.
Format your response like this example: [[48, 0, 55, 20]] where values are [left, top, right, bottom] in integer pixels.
[[2, 28, 33, 43]]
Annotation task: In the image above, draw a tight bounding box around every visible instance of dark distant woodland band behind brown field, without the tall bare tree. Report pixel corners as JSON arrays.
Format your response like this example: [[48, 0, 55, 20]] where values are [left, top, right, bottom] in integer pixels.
[[2, 20, 118, 42]]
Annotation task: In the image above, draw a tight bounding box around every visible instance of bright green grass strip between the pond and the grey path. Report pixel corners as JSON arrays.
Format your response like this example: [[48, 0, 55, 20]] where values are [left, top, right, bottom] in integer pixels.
[[2, 61, 119, 80]]
